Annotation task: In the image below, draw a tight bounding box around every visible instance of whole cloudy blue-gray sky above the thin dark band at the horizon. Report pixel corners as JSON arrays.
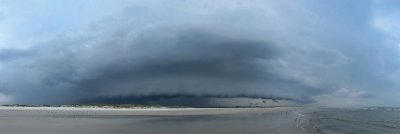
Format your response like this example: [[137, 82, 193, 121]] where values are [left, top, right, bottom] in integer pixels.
[[0, 0, 400, 106]]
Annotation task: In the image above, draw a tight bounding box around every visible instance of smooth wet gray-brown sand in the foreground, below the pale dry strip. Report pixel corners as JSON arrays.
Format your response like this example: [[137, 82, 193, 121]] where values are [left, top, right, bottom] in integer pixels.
[[0, 113, 305, 134]]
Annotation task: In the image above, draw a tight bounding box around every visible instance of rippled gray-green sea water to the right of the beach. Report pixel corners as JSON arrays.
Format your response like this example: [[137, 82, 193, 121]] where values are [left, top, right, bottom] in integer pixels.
[[298, 108, 400, 134]]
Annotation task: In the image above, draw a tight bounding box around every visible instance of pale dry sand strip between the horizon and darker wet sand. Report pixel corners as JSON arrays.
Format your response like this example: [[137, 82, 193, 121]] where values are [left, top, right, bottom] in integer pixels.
[[0, 107, 298, 116]]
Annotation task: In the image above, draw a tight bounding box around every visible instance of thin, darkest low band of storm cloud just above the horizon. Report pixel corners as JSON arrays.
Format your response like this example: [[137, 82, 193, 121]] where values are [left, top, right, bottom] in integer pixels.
[[80, 93, 315, 107]]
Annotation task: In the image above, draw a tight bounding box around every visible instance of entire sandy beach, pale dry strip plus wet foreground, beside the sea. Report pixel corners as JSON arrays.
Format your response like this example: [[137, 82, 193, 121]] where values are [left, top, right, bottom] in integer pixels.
[[0, 107, 306, 134]]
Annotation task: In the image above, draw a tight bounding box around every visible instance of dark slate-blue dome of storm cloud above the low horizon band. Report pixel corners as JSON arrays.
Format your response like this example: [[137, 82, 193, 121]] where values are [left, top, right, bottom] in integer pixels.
[[69, 31, 322, 102]]
